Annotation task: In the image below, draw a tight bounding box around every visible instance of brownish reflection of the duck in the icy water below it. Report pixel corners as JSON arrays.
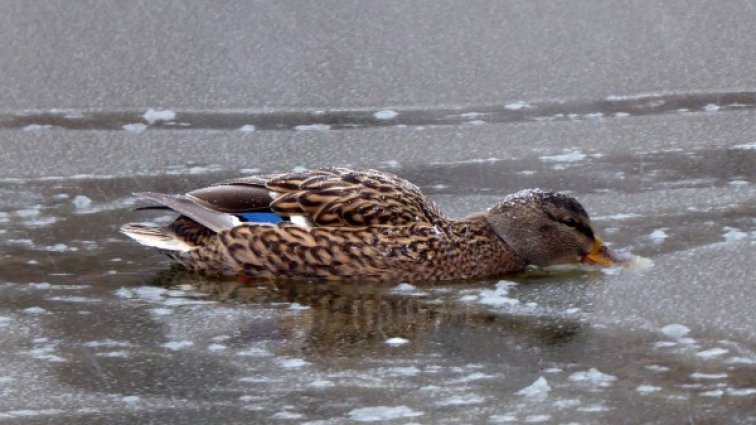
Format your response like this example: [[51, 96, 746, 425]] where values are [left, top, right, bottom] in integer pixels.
[[152, 270, 583, 355]]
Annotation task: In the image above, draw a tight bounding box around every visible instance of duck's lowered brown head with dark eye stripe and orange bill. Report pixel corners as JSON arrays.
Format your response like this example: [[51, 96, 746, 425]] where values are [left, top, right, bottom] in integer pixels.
[[486, 189, 616, 267]]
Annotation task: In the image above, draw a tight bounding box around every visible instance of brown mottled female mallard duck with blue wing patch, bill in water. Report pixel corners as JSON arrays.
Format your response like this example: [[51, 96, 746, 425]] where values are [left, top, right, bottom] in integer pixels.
[[121, 168, 615, 282]]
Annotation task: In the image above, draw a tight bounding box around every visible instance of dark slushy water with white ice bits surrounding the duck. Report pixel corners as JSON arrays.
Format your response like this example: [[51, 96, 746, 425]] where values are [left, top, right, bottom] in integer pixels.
[[0, 137, 756, 424]]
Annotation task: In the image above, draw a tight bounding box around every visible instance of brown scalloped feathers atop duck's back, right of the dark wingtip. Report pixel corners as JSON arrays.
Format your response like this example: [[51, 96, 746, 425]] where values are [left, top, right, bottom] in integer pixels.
[[265, 168, 448, 227]]
